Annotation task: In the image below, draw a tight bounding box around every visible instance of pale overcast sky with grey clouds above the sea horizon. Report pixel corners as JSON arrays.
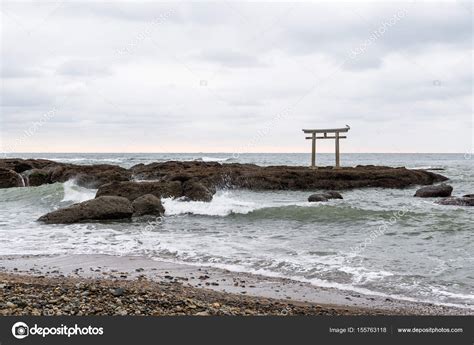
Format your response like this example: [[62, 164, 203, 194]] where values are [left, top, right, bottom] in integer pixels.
[[0, 1, 473, 153]]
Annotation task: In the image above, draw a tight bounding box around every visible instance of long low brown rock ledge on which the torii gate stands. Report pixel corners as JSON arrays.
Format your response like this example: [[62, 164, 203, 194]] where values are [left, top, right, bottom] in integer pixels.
[[130, 161, 447, 190]]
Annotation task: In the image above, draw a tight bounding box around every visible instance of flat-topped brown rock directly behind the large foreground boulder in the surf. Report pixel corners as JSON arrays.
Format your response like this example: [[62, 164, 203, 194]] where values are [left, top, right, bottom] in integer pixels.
[[96, 181, 183, 201]]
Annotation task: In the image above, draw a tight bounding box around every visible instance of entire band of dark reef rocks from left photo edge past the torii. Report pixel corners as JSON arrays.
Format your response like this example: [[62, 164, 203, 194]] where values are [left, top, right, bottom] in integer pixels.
[[0, 159, 447, 191]]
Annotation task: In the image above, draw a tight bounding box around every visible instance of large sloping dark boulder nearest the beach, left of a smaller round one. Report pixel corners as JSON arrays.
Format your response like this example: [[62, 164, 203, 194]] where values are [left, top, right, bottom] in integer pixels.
[[38, 196, 133, 224]]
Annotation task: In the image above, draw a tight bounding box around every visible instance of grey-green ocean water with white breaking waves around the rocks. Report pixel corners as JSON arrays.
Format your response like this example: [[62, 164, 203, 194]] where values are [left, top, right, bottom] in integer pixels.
[[0, 153, 474, 309]]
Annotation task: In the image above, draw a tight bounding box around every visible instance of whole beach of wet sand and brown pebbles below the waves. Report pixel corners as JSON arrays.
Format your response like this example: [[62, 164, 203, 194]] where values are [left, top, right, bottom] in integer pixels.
[[0, 255, 474, 315]]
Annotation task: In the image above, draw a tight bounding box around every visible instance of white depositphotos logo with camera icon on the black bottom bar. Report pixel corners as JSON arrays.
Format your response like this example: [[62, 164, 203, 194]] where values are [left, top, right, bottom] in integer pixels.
[[12, 322, 104, 339]]
